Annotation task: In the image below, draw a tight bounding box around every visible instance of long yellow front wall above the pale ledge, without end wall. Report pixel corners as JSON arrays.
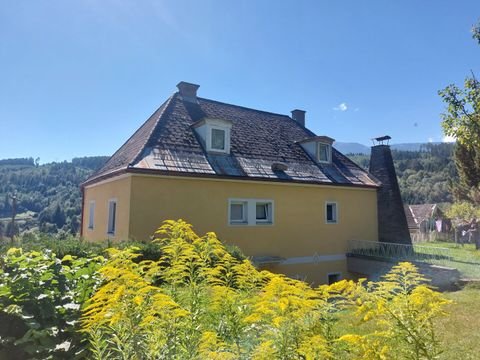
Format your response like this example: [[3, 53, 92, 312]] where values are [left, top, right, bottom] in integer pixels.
[[130, 175, 377, 250]]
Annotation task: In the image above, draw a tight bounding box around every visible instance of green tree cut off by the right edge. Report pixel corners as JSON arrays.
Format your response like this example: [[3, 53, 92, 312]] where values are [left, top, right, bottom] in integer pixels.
[[439, 22, 480, 203]]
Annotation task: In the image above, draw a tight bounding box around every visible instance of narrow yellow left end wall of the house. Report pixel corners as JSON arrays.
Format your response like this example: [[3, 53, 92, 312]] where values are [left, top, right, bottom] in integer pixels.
[[82, 176, 131, 241]]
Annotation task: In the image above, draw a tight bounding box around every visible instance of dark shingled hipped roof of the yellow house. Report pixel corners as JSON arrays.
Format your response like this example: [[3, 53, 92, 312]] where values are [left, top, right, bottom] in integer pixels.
[[84, 93, 379, 187]]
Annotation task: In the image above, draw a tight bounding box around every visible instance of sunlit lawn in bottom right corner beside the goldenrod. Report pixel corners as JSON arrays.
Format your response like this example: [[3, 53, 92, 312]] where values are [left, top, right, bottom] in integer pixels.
[[436, 285, 480, 360]]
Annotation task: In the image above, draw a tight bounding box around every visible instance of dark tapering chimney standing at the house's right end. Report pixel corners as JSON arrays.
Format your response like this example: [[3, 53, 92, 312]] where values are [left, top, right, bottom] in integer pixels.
[[370, 136, 412, 245]]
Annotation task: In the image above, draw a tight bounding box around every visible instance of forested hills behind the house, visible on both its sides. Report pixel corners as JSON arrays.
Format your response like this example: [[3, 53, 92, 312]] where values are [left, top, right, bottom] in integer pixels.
[[0, 143, 457, 237]]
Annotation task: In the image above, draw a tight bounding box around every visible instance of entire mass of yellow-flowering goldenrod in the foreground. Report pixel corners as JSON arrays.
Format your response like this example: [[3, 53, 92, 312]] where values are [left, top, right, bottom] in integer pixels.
[[82, 220, 448, 359]]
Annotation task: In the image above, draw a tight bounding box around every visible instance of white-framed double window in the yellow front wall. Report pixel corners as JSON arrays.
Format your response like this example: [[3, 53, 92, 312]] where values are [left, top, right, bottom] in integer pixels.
[[228, 199, 273, 226]]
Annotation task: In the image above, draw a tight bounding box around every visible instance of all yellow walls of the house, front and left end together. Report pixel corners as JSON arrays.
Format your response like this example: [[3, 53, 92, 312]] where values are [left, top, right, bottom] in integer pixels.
[[83, 174, 378, 284]]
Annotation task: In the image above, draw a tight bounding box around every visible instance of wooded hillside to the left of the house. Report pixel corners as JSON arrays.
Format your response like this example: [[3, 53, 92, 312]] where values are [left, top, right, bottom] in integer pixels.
[[0, 156, 107, 234]]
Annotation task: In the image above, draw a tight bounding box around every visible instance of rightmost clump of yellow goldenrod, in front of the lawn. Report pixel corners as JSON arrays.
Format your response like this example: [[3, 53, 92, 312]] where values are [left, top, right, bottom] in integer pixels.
[[341, 263, 450, 359]]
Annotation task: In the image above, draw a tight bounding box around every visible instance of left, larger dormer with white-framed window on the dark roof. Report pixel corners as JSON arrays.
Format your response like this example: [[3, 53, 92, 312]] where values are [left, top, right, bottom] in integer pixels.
[[192, 118, 232, 154]]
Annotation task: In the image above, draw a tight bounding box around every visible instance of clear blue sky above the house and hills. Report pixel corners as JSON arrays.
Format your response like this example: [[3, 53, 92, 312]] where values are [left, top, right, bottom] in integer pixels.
[[0, 0, 480, 162]]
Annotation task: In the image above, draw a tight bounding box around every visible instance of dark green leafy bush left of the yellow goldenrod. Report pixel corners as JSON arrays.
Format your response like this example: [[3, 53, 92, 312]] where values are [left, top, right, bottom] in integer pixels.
[[0, 248, 103, 358]]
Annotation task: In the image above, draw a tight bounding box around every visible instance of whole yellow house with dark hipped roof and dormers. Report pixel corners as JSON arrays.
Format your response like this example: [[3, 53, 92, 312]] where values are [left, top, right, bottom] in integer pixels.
[[82, 82, 379, 283]]
